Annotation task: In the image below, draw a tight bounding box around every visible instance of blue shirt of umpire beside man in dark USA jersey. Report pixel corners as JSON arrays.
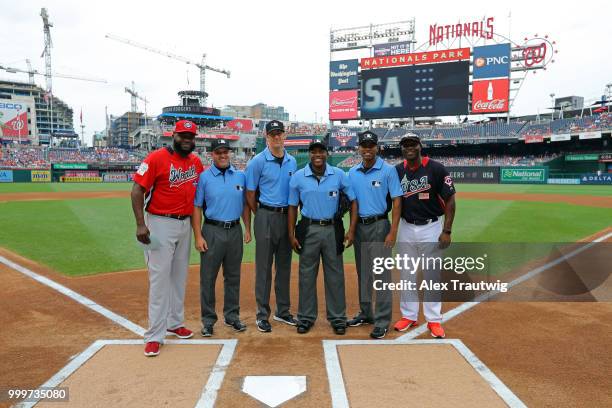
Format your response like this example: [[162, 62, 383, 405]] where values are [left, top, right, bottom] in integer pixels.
[[349, 157, 404, 217]]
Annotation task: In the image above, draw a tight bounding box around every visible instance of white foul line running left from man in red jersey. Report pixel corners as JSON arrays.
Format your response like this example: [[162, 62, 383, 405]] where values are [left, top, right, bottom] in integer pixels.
[[0, 256, 145, 343]]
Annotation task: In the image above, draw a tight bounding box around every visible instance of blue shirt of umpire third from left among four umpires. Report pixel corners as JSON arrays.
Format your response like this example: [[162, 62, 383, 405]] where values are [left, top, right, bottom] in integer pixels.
[[289, 164, 355, 220]]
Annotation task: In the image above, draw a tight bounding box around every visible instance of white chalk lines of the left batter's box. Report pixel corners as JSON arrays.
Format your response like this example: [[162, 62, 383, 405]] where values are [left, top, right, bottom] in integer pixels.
[[15, 339, 238, 408]]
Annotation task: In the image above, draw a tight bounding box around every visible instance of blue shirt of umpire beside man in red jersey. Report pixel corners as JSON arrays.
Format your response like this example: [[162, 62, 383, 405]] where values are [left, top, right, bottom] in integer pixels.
[[194, 164, 246, 221]]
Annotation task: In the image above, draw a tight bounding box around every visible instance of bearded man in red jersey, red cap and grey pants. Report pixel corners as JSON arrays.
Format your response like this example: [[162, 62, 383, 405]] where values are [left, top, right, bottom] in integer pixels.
[[132, 120, 203, 356]]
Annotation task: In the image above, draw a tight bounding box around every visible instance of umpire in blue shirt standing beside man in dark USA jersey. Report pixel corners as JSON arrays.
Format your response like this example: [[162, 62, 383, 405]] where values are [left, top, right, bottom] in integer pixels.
[[348, 131, 403, 339]]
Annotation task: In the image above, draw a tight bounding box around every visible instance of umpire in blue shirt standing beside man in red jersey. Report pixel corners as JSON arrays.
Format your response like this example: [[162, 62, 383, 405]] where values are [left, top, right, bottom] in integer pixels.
[[191, 139, 251, 337]]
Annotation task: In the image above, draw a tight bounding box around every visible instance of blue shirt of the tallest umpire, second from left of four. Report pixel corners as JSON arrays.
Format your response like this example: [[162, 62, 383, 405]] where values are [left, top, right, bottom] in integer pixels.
[[246, 147, 297, 207]]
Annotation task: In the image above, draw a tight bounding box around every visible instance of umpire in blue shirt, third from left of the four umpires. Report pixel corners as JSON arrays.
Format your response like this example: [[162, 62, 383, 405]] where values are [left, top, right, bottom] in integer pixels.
[[288, 141, 357, 334]]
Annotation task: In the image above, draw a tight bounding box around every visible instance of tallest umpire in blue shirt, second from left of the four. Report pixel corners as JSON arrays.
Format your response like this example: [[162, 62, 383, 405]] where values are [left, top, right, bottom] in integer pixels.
[[246, 120, 297, 332]]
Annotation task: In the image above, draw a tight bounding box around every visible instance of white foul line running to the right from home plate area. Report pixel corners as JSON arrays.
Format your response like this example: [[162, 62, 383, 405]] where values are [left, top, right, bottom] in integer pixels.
[[394, 232, 612, 342]]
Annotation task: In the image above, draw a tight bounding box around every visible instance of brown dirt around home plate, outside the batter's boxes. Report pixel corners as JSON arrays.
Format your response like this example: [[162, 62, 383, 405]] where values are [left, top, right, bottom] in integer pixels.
[[0, 226, 612, 407]]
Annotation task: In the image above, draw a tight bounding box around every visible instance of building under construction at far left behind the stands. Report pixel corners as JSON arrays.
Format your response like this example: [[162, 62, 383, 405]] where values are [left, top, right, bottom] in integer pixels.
[[0, 80, 78, 145]]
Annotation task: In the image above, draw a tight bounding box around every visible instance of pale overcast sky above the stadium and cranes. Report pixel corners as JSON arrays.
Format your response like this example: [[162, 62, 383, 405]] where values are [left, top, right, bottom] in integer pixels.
[[0, 0, 612, 145]]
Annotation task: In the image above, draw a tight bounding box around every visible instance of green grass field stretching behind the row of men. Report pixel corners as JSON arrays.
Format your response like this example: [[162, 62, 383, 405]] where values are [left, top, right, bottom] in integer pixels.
[[0, 192, 612, 276]]
